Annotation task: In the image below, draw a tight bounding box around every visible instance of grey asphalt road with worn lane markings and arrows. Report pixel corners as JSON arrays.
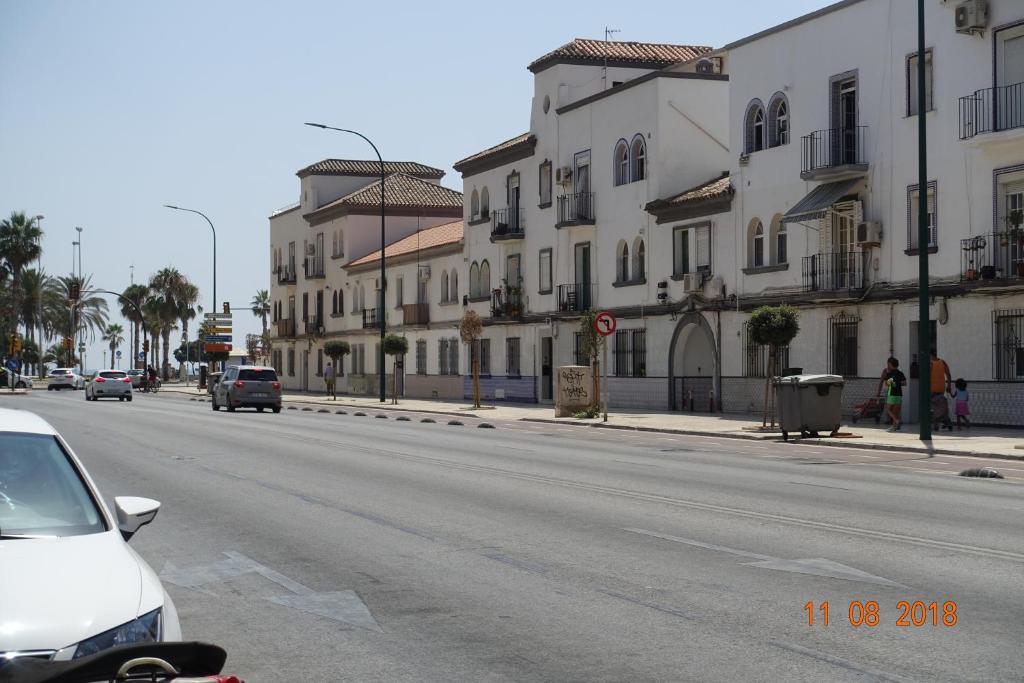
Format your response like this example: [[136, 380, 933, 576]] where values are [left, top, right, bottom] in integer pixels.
[[9, 392, 1024, 682]]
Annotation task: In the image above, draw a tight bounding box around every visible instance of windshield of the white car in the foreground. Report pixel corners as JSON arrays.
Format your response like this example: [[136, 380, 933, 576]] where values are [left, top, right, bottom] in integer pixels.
[[0, 432, 106, 538]]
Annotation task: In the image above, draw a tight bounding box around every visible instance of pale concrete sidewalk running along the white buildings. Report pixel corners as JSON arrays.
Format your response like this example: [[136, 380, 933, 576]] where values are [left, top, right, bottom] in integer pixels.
[[153, 384, 1024, 460]]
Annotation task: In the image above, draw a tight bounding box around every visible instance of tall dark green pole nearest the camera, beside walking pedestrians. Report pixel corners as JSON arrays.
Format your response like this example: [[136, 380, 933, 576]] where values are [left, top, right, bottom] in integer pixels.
[[918, 0, 932, 441]]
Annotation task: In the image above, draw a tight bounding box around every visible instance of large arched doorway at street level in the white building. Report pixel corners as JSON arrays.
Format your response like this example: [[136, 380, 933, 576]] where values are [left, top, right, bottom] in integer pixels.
[[669, 312, 722, 412]]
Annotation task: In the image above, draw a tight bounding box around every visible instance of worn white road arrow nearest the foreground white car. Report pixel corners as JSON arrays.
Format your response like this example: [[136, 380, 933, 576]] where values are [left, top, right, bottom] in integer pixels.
[[160, 551, 382, 633]]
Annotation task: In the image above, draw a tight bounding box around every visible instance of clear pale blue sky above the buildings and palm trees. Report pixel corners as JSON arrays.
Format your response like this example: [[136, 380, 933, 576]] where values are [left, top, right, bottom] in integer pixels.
[[0, 0, 828, 368]]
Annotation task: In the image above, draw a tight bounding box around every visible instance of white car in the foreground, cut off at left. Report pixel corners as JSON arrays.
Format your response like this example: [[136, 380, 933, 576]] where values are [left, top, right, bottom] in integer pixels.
[[0, 409, 181, 669]]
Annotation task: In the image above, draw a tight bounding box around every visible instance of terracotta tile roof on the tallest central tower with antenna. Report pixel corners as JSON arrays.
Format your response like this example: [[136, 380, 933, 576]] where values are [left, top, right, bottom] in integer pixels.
[[529, 38, 712, 74]]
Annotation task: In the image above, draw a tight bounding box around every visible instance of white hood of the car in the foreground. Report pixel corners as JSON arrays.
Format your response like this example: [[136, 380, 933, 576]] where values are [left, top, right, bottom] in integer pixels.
[[0, 530, 163, 652]]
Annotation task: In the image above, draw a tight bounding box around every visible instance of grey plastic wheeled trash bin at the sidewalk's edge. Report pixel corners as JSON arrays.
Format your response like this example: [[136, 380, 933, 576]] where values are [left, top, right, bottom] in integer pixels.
[[775, 375, 845, 440]]
